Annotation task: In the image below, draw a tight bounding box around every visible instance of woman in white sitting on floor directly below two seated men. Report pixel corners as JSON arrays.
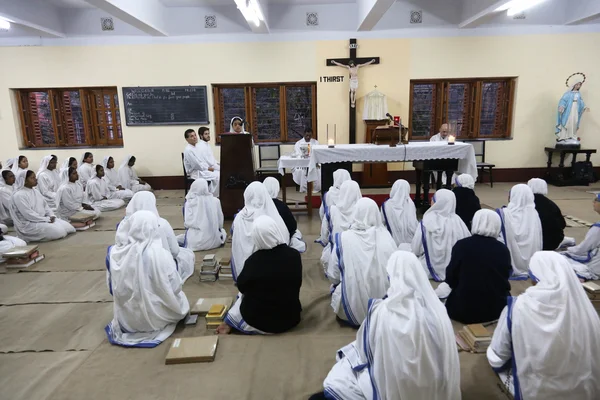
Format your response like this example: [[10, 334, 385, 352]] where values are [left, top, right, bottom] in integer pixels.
[[177, 178, 227, 251]]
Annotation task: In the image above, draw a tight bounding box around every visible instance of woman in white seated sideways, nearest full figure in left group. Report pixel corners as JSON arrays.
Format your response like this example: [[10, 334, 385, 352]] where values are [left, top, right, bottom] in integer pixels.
[[10, 171, 75, 242]]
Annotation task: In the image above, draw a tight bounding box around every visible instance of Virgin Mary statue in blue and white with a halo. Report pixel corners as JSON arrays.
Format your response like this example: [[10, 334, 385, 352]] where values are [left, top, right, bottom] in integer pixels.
[[555, 72, 589, 147]]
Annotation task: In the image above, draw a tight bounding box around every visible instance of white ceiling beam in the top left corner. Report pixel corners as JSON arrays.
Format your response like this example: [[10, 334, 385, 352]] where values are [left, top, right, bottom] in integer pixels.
[[0, 0, 67, 38]]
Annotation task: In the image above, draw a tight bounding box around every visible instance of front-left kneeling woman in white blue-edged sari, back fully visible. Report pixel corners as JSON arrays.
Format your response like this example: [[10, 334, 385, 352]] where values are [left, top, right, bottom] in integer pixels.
[[105, 211, 190, 348]]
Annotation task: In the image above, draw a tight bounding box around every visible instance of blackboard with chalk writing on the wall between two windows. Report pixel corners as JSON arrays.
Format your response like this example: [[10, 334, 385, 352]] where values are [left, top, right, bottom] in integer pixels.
[[123, 86, 208, 126]]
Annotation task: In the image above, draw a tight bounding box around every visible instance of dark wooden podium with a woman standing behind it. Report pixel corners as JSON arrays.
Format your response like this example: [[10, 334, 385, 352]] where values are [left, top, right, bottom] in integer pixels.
[[219, 133, 256, 218]]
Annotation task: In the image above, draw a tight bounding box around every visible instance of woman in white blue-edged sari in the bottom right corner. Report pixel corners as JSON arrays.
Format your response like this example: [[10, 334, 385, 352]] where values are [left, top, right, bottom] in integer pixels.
[[487, 251, 600, 400]]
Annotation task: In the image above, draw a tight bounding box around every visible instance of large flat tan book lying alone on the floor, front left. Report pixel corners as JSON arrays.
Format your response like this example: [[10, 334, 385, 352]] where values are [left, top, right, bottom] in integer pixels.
[[165, 336, 219, 365]]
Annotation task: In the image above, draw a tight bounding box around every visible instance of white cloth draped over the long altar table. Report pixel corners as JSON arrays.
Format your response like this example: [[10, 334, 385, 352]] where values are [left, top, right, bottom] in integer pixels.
[[310, 142, 477, 182]]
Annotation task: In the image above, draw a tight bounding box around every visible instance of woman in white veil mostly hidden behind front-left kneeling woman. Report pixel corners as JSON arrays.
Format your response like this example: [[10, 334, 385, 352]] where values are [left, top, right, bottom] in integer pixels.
[[121, 192, 196, 282]]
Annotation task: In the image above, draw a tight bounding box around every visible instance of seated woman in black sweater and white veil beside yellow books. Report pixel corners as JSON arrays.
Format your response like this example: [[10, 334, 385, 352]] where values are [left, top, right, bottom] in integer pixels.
[[217, 215, 302, 334]]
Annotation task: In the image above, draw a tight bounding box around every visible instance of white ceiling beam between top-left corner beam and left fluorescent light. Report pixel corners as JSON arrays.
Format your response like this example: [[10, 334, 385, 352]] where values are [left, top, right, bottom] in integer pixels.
[[85, 0, 169, 36]]
